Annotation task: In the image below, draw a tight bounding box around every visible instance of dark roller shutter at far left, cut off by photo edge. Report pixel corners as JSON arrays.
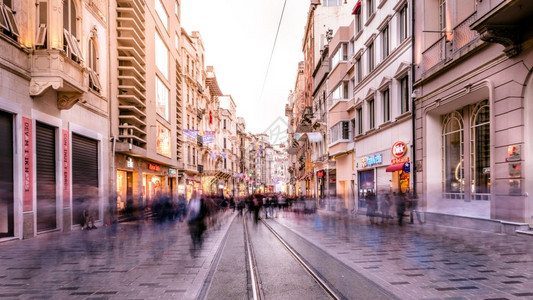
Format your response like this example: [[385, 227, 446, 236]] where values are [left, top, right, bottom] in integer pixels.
[[0, 111, 14, 238]]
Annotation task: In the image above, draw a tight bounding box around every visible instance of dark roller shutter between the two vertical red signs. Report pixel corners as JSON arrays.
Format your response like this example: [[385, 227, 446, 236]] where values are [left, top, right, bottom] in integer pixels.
[[35, 122, 57, 231]]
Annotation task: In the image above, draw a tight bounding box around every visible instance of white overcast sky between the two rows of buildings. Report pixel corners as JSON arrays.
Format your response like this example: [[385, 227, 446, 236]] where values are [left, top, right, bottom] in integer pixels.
[[181, 0, 309, 137]]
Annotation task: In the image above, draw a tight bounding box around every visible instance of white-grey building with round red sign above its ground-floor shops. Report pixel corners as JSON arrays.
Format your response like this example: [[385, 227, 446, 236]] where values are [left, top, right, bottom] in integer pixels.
[[347, 0, 414, 209]]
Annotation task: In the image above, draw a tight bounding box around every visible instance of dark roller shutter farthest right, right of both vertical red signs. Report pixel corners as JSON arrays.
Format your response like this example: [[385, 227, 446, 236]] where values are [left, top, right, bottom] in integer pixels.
[[72, 133, 99, 224]]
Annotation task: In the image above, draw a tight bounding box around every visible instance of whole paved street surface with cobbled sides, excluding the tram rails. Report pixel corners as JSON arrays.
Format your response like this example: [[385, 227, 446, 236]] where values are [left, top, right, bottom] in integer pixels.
[[0, 211, 533, 299]]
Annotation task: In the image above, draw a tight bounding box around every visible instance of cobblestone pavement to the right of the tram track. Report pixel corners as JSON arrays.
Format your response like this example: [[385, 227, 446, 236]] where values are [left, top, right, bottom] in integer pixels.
[[276, 212, 533, 299]]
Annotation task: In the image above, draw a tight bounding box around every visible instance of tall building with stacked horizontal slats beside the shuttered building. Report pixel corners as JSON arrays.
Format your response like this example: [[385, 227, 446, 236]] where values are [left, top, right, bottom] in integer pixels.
[[108, 0, 184, 215]]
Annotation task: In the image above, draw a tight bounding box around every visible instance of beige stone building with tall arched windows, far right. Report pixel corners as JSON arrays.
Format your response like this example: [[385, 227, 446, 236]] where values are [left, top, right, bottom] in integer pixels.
[[414, 0, 533, 227]]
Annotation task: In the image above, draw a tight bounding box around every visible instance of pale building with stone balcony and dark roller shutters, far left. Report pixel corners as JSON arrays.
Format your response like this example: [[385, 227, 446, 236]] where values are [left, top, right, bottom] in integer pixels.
[[0, 0, 111, 239]]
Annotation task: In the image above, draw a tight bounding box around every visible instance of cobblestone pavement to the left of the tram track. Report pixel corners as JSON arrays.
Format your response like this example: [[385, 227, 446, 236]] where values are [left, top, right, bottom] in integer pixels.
[[0, 214, 233, 299]]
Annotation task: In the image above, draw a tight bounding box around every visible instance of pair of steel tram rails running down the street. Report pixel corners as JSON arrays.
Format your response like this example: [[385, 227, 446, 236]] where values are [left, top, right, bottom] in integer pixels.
[[243, 218, 347, 300]]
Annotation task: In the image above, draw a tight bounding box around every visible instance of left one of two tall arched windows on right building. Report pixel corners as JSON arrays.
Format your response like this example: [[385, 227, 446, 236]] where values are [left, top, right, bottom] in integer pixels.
[[442, 111, 465, 199]]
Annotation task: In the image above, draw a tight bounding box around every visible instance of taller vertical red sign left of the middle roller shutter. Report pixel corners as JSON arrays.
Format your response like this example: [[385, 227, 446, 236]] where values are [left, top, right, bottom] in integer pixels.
[[22, 117, 33, 212]]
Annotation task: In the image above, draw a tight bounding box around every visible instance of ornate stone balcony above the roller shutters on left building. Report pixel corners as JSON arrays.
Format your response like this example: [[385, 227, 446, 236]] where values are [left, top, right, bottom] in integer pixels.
[[30, 49, 89, 109]]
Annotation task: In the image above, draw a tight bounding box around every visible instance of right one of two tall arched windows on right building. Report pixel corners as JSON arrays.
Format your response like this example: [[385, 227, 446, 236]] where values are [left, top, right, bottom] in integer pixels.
[[470, 100, 490, 200]]
